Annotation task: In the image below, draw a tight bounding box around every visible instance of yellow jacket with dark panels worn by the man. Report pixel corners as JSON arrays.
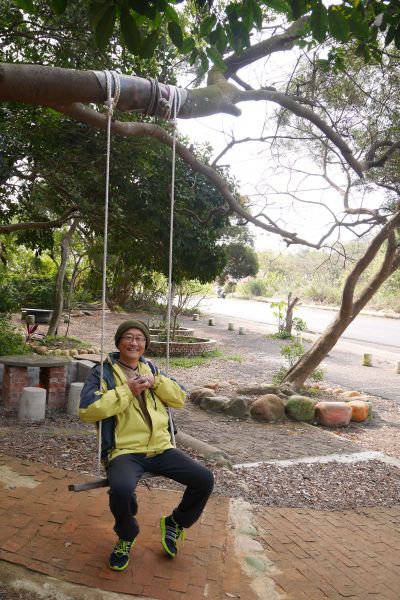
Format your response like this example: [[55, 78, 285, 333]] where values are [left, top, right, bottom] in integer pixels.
[[79, 353, 186, 462]]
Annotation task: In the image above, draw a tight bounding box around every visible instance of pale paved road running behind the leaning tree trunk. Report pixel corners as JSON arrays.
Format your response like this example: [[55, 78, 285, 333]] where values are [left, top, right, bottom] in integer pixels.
[[201, 298, 400, 405]]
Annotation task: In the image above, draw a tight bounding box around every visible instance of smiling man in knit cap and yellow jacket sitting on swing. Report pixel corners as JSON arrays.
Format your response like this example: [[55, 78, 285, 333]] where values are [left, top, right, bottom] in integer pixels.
[[79, 320, 214, 571]]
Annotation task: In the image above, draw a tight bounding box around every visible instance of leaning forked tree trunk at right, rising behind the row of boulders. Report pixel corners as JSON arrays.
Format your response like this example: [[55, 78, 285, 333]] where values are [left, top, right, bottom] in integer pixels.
[[284, 213, 400, 388]]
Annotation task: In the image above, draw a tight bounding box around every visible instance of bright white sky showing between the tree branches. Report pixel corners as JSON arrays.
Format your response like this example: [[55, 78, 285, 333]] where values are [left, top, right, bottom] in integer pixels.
[[178, 42, 382, 250]]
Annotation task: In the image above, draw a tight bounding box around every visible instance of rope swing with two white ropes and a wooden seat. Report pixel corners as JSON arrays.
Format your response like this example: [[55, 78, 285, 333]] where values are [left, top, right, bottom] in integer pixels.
[[68, 70, 181, 492]]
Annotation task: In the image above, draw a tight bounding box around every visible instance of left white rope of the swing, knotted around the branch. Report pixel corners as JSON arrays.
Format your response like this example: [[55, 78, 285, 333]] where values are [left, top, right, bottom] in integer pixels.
[[97, 71, 121, 475]]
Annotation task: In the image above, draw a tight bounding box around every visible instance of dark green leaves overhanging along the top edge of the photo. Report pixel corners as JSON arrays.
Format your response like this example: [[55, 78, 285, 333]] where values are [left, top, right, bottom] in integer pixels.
[[14, 0, 400, 72]]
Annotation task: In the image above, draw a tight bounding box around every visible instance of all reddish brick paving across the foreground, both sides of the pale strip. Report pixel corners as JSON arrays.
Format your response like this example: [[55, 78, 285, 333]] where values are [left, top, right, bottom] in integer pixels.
[[0, 455, 400, 600]]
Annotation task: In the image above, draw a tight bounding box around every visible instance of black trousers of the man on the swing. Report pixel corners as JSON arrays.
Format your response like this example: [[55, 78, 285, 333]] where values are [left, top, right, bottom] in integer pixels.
[[107, 448, 214, 541]]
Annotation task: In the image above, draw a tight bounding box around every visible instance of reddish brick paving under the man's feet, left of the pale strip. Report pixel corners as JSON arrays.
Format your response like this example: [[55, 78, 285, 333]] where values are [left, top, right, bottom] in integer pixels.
[[0, 455, 256, 600]]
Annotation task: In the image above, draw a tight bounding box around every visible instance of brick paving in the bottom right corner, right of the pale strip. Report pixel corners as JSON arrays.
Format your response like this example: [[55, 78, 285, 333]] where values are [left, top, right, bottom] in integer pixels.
[[256, 505, 400, 600]]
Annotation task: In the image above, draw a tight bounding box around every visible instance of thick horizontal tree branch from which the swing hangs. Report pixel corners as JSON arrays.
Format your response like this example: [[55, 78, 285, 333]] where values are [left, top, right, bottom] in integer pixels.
[[0, 64, 363, 177]]
